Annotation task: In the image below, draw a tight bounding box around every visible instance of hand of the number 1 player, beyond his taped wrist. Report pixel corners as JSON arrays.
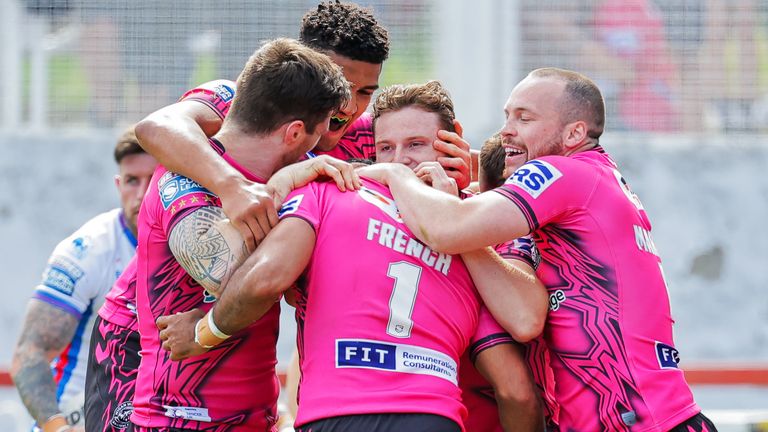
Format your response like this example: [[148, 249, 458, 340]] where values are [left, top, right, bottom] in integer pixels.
[[156, 309, 208, 360]]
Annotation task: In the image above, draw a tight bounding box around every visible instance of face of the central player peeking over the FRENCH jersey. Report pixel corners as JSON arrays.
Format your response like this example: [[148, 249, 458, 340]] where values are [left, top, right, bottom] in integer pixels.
[[375, 107, 445, 169]]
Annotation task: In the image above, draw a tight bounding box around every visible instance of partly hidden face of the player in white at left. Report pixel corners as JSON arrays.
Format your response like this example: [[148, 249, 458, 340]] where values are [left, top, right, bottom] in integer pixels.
[[115, 153, 157, 235]]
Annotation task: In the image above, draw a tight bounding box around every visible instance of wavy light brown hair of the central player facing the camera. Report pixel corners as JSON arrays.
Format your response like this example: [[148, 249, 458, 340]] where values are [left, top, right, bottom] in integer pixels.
[[373, 81, 456, 132]]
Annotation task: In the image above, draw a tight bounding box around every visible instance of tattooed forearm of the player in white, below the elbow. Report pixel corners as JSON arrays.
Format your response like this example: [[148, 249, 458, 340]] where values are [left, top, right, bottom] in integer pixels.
[[11, 351, 59, 425]]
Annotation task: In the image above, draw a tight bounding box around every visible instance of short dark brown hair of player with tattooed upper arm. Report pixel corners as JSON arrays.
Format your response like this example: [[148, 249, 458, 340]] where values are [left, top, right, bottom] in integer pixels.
[[227, 39, 350, 133]]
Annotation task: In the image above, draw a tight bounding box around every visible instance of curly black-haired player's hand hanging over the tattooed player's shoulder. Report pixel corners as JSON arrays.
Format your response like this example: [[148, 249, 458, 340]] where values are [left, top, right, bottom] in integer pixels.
[[219, 179, 278, 252]]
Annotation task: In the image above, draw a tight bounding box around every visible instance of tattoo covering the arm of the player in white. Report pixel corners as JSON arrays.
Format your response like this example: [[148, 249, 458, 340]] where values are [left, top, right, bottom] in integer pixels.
[[13, 300, 78, 425]]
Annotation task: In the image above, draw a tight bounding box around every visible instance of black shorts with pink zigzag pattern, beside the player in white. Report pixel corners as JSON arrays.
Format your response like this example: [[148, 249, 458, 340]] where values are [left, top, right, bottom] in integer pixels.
[[85, 317, 141, 432]]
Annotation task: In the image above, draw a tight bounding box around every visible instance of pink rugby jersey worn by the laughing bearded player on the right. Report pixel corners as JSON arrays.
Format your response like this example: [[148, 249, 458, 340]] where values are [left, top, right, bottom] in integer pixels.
[[495, 148, 700, 432]]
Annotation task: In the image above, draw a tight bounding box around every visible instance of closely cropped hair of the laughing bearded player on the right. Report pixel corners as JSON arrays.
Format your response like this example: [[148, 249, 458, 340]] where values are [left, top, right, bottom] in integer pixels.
[[529, 68, 605, 139]]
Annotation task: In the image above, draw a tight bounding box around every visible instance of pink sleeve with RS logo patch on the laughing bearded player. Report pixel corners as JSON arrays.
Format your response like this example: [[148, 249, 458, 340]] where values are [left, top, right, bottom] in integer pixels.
[[493, 156, 599, 232]]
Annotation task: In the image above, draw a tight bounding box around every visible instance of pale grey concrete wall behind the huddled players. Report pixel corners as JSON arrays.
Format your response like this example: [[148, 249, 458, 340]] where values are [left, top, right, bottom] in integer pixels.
[[0, 132, 768, 369]]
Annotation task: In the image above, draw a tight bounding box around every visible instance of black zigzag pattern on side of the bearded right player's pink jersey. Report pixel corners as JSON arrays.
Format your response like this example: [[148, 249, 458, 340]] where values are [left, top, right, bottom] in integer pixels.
[[536, 226, 646, 431]]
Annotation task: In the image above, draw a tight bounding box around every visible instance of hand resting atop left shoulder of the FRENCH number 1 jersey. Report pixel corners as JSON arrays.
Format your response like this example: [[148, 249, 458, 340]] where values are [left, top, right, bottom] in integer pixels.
[[267, 155, 360, 205]]
